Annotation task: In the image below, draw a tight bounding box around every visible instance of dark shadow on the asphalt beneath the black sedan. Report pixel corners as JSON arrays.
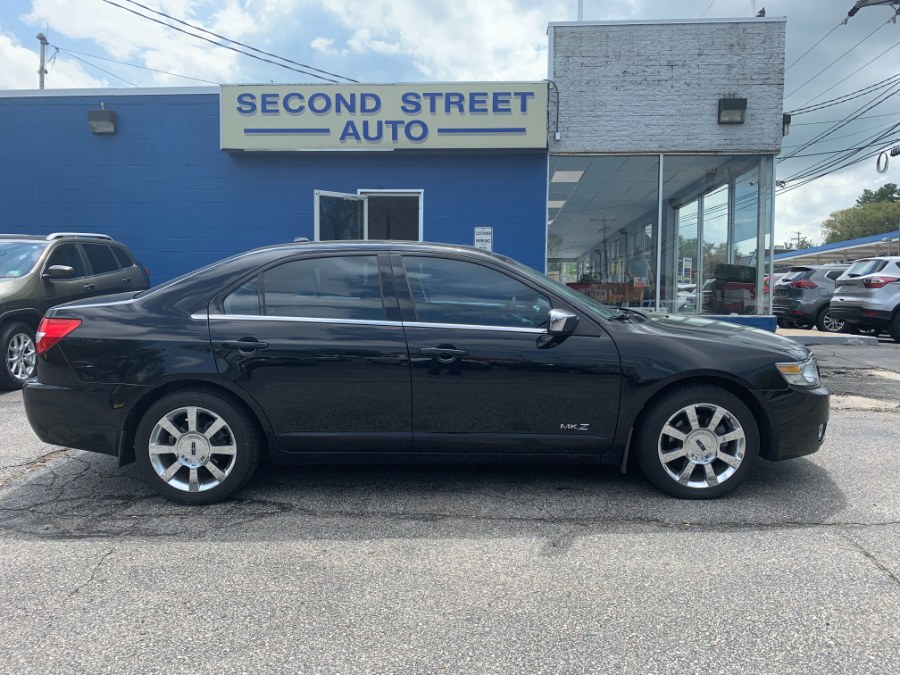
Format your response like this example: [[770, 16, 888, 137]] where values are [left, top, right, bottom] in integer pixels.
[[0, 451, 845, 541]]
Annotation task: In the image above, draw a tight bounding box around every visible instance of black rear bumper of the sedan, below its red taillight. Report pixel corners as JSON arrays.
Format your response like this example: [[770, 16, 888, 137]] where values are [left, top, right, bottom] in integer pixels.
[[22, 380, 125, 456]]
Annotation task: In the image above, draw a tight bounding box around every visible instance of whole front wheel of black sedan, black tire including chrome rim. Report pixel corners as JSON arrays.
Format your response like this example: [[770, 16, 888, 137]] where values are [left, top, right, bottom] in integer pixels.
[[634, 386, 759, 499]]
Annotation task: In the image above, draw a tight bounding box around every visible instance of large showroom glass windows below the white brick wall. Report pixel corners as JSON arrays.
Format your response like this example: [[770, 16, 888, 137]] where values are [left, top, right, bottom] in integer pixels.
[[547, 155, 772, 314]]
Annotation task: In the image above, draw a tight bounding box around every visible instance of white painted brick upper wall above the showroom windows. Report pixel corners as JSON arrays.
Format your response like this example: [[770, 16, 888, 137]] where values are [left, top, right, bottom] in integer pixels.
[[549, 18, 785, 154]]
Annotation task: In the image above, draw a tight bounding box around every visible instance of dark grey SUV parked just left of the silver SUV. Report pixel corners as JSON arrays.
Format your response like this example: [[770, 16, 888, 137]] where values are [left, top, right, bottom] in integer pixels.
[[772, 264, 849, 333]]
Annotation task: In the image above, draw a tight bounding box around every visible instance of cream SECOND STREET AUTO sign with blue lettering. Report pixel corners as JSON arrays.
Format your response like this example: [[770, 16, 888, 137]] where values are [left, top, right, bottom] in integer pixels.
[[219, 82, 547, 150]]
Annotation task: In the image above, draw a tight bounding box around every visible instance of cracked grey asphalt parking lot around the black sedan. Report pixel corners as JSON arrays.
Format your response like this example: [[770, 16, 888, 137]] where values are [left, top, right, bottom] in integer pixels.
[[0, 343, 900, 673]]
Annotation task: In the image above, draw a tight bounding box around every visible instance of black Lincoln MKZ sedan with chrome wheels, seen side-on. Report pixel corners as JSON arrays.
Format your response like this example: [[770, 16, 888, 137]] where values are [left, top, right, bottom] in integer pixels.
[[24, 242, 828, 504]]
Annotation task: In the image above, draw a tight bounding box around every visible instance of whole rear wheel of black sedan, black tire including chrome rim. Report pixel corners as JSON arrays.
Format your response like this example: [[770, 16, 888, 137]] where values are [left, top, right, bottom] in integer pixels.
[[135, 390, 262, 504]]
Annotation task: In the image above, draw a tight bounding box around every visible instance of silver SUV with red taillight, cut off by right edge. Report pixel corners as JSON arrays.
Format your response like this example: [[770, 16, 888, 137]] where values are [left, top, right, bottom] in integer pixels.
[[831, 256, 900, 342]]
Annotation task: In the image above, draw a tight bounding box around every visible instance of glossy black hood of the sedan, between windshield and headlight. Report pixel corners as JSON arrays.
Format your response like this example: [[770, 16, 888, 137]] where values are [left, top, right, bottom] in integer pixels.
[[624, 312, 810, 360]]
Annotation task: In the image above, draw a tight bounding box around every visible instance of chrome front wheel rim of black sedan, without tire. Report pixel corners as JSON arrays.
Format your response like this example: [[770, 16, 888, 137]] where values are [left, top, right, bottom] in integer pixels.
[[657, 403, 747, 489]]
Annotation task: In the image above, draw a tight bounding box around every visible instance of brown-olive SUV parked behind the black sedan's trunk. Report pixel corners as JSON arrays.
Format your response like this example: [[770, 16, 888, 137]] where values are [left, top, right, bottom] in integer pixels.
[[0, 232, 150, 389]]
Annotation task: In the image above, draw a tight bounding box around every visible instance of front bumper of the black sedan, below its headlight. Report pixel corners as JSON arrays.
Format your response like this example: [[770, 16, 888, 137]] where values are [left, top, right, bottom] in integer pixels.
[[762, 386, 831, 460]]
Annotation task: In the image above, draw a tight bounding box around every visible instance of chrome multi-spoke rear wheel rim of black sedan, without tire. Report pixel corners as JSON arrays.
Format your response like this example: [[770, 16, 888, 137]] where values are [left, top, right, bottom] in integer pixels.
[[148, 406, 238, 492]]
